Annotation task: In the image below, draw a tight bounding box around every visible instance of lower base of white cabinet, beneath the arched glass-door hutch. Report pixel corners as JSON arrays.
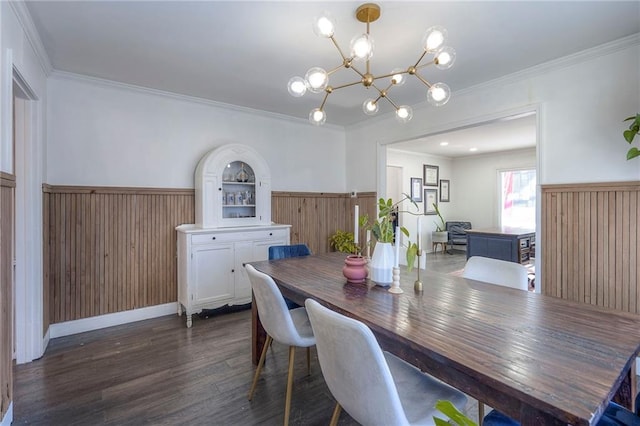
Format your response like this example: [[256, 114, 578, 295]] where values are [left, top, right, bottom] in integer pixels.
[[176, 225, 290, 327]]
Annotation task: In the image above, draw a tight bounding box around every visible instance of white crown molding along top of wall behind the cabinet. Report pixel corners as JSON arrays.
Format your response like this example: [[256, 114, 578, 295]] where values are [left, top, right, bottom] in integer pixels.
[[49, 69, 344, 131]]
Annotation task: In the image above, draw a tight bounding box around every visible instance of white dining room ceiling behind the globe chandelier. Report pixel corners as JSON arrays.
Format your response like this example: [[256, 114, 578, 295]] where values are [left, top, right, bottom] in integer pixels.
[[26, 0, 640, 155]]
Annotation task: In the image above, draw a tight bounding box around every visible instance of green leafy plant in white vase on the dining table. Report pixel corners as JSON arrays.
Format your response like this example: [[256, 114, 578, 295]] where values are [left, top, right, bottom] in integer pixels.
[[359, 194, 418, 284]]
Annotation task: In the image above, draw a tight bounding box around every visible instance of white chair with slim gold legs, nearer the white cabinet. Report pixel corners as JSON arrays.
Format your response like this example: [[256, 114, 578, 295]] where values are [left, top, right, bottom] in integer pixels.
[[245, 264, 316, 426]]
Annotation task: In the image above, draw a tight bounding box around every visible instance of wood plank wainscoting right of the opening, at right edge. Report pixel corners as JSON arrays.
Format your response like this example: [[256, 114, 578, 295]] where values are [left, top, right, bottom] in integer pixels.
[[541, 181, 640, 313]]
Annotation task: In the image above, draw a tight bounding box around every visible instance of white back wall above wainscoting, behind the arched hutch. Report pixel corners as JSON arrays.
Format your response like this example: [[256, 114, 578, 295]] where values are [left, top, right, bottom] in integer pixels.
[[46, 74, 347, 192]]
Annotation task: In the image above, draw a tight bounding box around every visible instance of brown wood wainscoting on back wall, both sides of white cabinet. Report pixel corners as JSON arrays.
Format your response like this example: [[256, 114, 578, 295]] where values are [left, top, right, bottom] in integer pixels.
[[43, 185, 376, 330]]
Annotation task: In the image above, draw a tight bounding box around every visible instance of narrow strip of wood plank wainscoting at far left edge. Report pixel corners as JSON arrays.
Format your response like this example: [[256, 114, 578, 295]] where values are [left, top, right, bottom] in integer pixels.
[[0, 172, 16, 420]]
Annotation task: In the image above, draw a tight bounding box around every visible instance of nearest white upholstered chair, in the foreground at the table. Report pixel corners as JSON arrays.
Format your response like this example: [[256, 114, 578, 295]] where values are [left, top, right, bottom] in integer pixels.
[[305, 299, 467, 426]]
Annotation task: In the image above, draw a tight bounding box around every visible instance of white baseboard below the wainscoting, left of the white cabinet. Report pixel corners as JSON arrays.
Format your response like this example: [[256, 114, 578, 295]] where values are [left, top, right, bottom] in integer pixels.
[[49, 302, 178, 339]]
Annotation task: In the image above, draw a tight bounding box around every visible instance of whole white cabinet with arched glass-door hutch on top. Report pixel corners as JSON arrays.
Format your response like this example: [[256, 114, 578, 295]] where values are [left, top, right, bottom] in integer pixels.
[[176, 144, 291, 327]]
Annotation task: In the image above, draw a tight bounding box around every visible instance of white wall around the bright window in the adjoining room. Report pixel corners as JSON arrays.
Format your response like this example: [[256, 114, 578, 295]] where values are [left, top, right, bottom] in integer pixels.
[[452, 149, 536, 228]]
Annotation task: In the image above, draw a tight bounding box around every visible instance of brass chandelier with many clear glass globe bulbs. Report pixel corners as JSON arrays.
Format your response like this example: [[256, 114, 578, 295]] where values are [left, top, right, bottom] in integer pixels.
[[288, 3, 456, 125]]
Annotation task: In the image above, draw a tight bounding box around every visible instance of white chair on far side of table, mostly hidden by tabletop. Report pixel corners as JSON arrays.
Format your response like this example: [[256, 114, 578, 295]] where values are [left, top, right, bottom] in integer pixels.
[[462, 256, 529, 426]]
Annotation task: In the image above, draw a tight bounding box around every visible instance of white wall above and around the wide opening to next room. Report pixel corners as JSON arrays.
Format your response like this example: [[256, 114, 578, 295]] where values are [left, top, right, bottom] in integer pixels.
[[347, 34, 640, 191]]
